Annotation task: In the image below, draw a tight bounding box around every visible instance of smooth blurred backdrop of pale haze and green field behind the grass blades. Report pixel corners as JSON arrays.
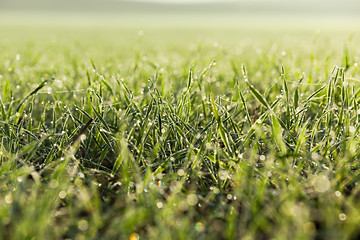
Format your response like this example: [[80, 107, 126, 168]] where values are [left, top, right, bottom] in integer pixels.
[[0, 0, 360, 73]]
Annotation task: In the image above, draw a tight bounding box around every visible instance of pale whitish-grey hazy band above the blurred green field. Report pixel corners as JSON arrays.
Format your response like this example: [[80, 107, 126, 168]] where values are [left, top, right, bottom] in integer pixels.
[[0, 0, 360, 29]]
